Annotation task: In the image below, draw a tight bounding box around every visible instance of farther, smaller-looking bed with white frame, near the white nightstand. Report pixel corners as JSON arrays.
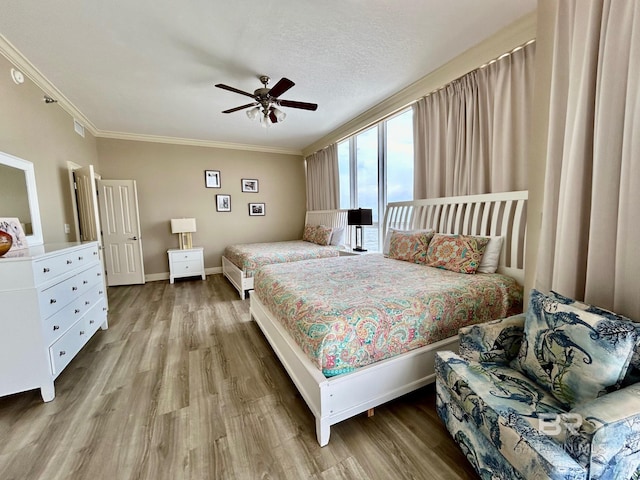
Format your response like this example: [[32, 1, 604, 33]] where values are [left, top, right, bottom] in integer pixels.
[[222, 210, 351, 300]]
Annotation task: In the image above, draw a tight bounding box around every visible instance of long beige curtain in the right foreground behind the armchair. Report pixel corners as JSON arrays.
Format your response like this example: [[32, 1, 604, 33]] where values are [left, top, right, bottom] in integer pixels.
[[536, 0, 640, 320]]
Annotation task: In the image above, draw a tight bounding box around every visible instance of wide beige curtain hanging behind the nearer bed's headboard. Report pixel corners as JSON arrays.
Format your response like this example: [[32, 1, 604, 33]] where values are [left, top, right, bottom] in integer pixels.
[[413, 43, 535, 198]]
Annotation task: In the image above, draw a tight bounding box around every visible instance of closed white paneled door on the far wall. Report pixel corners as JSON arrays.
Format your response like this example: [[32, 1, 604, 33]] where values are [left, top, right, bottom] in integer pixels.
[[98, 180, 144, 286]]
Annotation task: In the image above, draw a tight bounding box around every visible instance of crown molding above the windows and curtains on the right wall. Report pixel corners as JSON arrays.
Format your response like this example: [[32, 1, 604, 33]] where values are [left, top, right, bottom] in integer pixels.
[[302, 11, 537, 157]]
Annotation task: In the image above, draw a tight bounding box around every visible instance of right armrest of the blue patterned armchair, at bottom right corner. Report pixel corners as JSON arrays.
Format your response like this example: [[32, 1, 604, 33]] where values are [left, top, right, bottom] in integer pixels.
[[565, 383, 640, 479]]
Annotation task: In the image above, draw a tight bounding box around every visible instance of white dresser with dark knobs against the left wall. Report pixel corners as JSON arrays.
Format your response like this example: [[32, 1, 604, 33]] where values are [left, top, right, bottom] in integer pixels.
[[0, 242, 108, 402]]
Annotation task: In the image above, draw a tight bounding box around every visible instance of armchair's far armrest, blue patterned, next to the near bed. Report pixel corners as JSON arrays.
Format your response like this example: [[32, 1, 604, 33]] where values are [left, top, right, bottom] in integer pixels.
[[458, 313, 525, 364]]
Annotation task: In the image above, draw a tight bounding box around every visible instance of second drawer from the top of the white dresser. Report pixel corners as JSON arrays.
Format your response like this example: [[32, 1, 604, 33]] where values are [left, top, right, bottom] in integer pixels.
[[38, 263, 103, 318]]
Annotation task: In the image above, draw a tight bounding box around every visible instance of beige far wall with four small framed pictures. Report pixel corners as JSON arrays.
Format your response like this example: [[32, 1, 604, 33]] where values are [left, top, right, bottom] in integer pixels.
[[97, 137, 306, 280]]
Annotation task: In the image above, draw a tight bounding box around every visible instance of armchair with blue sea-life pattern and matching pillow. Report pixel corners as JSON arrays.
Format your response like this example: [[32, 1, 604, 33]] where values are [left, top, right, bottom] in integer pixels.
[[436, 290, 640, 480]]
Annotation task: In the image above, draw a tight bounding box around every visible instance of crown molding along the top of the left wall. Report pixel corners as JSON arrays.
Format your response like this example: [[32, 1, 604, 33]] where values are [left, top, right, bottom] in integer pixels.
[[0, 34, 97, 136]]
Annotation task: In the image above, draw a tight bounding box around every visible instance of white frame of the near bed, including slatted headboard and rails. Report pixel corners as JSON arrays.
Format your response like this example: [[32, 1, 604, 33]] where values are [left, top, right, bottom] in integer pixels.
[[250, 191, 527, 447]]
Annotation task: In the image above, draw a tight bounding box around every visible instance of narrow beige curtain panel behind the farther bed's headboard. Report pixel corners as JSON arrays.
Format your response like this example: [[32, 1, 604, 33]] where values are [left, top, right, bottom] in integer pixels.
[[305, 143, 340, 210]]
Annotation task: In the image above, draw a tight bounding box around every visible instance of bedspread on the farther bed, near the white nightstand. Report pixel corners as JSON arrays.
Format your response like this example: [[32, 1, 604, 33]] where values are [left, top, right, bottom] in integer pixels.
[[224, 240, 338, 277]]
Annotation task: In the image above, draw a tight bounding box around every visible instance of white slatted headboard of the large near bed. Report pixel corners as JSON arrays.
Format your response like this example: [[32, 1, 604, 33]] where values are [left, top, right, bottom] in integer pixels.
[[382, 191, 528, 285]]
